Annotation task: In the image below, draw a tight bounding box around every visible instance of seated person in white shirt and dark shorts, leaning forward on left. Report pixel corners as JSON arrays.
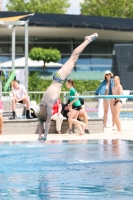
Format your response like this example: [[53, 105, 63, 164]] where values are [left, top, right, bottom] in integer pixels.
[[10, 80, 33, 119]]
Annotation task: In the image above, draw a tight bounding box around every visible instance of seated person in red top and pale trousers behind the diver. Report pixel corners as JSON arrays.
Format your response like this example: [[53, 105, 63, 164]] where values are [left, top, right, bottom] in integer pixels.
[[51, 98, 63, 134]]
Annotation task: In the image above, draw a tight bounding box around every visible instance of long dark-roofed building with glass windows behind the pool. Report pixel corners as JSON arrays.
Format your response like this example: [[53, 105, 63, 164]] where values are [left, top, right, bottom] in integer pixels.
[[0, 12, 133, 81]]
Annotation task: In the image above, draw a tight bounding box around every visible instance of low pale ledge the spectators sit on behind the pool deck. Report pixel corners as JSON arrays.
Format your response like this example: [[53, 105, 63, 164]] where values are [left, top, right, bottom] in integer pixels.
[[3, 119, 104, 135]]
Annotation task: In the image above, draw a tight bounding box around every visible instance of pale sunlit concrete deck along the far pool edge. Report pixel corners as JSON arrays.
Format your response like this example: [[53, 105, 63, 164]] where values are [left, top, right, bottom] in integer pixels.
[[0, 119, 133, 142]]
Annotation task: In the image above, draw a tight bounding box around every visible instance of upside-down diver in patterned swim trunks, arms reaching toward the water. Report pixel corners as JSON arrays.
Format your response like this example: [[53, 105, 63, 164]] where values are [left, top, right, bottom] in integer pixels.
[[36, 33, 98, 140]]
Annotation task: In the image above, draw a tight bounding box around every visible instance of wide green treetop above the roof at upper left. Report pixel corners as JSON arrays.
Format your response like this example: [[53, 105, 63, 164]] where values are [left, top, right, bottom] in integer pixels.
[[6, 0, 70, 14]]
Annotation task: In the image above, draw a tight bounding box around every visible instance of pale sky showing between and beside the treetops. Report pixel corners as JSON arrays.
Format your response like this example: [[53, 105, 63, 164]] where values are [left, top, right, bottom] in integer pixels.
[[2, 0, 84, 15]]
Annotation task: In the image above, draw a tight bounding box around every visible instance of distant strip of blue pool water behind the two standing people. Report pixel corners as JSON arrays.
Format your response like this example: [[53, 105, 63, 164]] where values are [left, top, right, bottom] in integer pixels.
[[87, 111, 133, 119]]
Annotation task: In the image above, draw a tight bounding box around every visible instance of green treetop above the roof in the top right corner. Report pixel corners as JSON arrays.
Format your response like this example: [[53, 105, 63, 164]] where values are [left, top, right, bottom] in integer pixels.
[[80, 0, 133, 18]]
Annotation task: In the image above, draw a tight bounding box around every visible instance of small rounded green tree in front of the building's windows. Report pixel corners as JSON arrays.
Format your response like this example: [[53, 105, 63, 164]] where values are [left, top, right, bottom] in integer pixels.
[[29, 47, 61, 67]]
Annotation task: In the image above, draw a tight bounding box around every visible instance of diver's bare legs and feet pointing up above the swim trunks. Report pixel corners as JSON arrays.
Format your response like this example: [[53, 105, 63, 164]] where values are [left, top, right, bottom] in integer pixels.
[[58, 33, 98, 80]]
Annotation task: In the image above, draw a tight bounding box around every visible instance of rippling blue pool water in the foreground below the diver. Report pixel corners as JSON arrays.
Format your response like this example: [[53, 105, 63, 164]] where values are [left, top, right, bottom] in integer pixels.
[[0, 140, 133, 200]]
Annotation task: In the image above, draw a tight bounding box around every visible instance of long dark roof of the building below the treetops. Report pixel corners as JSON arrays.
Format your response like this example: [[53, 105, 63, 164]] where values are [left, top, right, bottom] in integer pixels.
[[0, 11, 133, 32]]
